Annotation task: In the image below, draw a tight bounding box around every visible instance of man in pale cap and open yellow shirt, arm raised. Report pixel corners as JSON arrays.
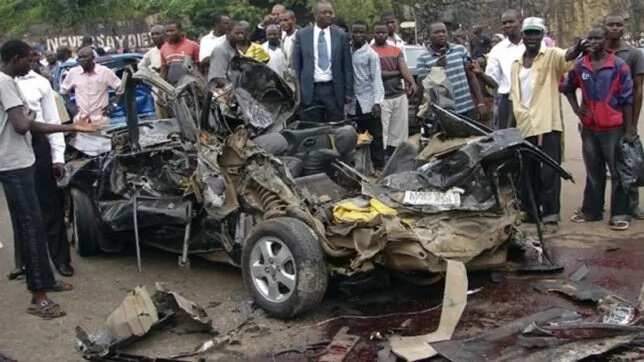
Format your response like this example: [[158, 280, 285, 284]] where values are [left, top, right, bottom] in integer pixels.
[[510, 17, 583, 232]]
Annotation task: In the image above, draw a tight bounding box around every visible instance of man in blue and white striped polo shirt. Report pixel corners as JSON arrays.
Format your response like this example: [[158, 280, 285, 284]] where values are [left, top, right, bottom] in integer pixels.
[[417, 22, 487, 119]]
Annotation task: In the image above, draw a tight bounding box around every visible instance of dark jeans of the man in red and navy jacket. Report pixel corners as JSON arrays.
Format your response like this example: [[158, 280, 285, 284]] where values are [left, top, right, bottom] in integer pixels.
[[581, 128, 631, 220]]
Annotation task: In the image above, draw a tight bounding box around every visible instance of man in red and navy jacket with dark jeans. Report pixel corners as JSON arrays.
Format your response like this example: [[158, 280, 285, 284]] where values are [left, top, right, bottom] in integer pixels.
[[561, 27, 637, 230]]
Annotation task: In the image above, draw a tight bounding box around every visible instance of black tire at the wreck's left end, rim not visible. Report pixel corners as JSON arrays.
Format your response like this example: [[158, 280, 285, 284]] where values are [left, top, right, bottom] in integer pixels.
[[70, 189, 105, 257]]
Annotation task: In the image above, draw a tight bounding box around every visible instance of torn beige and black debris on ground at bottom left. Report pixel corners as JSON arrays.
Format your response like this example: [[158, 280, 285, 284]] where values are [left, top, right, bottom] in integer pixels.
[[76, 285, 212, 360]]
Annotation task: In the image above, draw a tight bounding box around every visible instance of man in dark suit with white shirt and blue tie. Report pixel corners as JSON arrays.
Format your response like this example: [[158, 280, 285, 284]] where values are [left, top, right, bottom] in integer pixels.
[[292, 1, 353, 122]]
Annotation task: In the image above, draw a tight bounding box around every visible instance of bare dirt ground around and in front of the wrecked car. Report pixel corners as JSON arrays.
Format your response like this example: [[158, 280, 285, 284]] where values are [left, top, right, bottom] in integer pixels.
[[0, 108, 644, 362]]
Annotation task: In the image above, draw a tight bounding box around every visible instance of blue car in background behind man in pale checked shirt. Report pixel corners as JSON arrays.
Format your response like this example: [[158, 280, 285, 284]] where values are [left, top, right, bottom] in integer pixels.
[[53, 53, 156, 124]]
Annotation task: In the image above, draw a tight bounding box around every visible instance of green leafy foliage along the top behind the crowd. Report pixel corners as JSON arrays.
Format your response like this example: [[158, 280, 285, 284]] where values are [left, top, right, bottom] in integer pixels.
[[0, 0, 392, 36]]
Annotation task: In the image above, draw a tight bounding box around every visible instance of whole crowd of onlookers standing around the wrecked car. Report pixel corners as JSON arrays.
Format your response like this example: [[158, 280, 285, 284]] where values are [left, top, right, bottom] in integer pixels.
[[0, 1, 644, 319]]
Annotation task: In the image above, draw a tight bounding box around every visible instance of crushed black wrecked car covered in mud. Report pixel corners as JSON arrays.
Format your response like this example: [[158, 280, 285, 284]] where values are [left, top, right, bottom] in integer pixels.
[[64, 58, 570, 318]]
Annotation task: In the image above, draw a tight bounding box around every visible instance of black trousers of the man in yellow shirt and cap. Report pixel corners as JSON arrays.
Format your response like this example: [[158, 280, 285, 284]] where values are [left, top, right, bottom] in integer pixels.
[[521, 132, 561, 222]]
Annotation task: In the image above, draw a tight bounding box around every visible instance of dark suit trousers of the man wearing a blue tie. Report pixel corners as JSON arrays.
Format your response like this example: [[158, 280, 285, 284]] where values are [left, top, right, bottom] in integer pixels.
[[300, 82, 344, 123]]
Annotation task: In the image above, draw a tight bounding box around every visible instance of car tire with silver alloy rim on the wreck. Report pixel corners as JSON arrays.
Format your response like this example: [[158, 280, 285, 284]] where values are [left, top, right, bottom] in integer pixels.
[[242, 217, 329, 319]]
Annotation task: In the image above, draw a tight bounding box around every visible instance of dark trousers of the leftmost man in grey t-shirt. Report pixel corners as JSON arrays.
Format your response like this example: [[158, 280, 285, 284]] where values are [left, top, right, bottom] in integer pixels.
[[0, 167, 54, 291]]
